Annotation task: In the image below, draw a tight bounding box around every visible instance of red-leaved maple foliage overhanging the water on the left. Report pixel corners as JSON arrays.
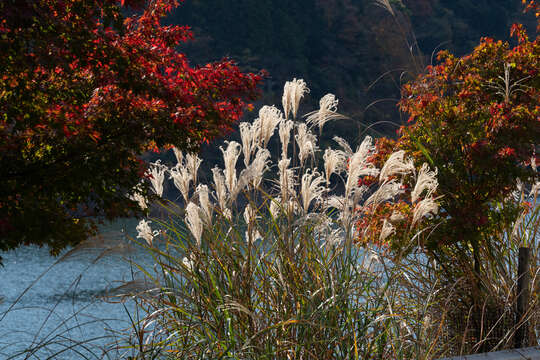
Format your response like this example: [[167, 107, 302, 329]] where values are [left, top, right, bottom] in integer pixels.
[[0, 0, 261, 255]]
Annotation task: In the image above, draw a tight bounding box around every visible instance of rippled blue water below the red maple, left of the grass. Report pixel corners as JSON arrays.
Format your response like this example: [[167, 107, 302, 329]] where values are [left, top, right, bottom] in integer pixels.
[[0, 220, 150, 360]]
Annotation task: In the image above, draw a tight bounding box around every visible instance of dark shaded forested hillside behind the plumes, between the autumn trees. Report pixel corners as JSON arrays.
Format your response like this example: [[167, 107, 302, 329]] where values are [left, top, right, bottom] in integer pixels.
[[169, 0, 528, 137]]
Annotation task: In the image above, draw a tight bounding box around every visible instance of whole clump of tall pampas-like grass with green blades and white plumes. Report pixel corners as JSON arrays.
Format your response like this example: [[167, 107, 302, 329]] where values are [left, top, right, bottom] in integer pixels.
[[123, 79, 437, 359]]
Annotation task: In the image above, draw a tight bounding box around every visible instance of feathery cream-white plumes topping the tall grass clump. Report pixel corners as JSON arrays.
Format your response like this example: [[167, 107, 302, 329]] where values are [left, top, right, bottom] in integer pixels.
[[133, 79, 438, 258]]
